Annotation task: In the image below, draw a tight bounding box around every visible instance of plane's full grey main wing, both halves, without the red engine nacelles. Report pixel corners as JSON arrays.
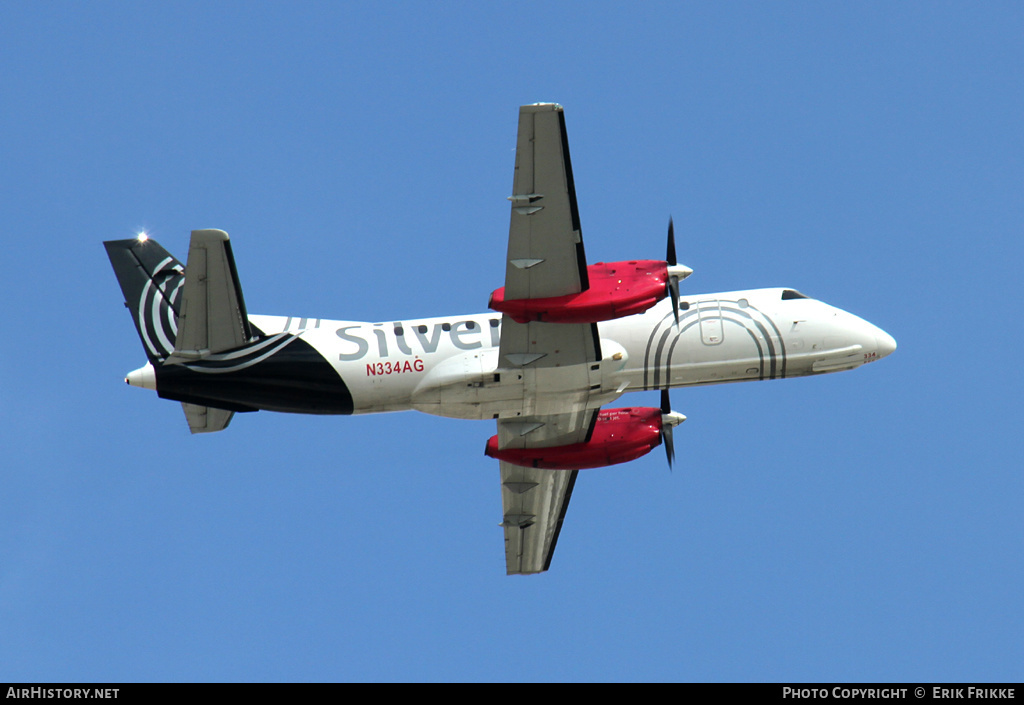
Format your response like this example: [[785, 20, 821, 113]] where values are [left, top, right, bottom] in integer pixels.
[[498, 103, 601, 575]]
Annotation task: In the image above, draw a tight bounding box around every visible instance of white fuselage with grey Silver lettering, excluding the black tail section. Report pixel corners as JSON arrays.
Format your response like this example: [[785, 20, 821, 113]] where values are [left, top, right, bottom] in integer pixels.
[[243, 289, 896, 419]]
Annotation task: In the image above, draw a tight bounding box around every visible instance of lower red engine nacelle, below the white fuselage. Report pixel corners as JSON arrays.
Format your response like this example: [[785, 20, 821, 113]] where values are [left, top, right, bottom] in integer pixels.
[[484, 407, 662, 470]]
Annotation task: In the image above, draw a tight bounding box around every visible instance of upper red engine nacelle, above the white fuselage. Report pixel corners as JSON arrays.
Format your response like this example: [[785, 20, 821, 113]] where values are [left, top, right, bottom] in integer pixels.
[[488, 259, 669, 323]]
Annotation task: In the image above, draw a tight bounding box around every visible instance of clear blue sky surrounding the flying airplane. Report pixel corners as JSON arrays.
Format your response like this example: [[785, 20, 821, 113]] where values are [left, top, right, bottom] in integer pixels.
[[0, 1, 1024, 681]]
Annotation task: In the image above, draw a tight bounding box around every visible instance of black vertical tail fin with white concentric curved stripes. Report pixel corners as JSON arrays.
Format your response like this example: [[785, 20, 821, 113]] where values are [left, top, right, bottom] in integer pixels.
[[103, 237, 185, 365]]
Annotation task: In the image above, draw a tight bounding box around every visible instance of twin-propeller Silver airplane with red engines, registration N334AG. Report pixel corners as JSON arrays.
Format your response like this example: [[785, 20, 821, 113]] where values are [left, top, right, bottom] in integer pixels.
[[104, 103, 896, 575]]
